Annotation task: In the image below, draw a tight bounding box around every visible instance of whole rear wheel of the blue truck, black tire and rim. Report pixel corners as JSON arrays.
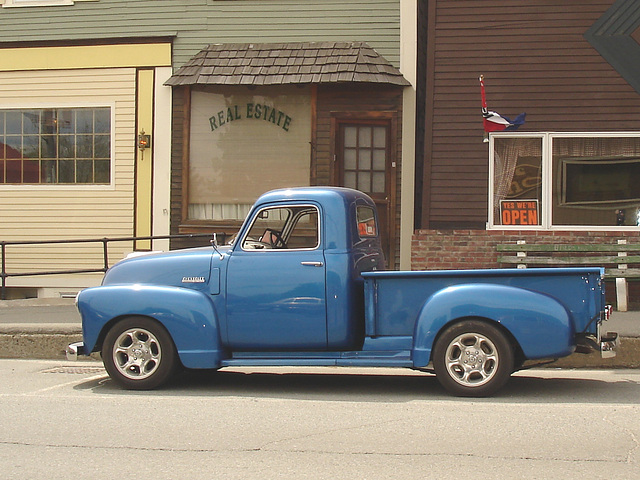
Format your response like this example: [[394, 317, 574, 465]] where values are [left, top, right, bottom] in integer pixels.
[[432, 320, 514, 397]]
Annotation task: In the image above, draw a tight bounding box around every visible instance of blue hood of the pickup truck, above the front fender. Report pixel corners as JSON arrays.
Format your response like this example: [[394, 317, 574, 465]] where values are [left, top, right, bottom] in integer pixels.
[[102, 247, 230, 290]]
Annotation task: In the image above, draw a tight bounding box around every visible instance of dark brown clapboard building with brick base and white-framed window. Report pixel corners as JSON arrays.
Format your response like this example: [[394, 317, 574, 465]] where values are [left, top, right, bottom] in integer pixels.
[[412, 0, 640, 308]]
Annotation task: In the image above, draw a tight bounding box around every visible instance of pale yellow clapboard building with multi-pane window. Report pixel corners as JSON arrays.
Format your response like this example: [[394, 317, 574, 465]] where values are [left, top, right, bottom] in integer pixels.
[[0, 43, 171, 296]]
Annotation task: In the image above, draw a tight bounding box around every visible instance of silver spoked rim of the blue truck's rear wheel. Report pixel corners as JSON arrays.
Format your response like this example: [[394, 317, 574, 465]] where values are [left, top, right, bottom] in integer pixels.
[[445, 333, 499, 387]]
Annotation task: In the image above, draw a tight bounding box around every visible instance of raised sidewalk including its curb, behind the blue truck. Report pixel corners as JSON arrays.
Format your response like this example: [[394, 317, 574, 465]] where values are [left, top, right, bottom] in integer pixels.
[[0, 298, 640, 368]]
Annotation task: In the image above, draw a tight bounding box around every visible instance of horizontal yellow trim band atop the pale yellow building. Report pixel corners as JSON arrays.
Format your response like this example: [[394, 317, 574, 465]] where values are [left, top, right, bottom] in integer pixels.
[[0, 43, 171, 72]]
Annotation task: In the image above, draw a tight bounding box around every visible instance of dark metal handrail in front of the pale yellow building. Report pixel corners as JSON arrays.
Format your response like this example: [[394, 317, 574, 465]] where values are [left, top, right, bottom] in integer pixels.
[[0, 233, 213, 300]]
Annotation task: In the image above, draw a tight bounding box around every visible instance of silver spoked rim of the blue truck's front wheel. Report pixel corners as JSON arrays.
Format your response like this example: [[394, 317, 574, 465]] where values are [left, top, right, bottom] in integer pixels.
[[113, 328, 162, 380]]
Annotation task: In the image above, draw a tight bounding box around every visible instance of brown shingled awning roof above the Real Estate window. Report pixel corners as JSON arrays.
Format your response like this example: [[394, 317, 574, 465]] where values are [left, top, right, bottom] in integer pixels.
[[165, 42, 409, 86]]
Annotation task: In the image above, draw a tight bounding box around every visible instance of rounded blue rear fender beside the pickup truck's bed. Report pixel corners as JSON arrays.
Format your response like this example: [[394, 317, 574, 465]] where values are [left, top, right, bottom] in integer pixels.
[[413, 284, 575, 367]]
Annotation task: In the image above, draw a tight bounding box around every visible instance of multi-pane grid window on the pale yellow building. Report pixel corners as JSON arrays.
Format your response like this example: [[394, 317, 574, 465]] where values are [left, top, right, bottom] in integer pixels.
[[0, 107, 111, 185]]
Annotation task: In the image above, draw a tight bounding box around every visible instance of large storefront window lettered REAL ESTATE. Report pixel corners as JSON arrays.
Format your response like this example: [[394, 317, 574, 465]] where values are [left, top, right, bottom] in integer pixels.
[[188, 86, 311, 222]]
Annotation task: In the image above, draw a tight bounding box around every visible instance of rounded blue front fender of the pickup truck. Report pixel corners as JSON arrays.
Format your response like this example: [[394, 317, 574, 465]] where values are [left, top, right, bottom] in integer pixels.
[[78, 285, 223, 368]]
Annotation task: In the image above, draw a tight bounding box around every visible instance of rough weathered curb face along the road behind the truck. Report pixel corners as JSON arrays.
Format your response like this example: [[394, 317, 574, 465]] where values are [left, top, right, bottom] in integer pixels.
[[0, 330, 640, 369]]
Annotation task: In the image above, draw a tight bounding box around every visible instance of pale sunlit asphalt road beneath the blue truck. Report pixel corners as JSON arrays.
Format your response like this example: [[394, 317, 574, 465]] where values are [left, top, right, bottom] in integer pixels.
[[0, 360, 640, 480]]
